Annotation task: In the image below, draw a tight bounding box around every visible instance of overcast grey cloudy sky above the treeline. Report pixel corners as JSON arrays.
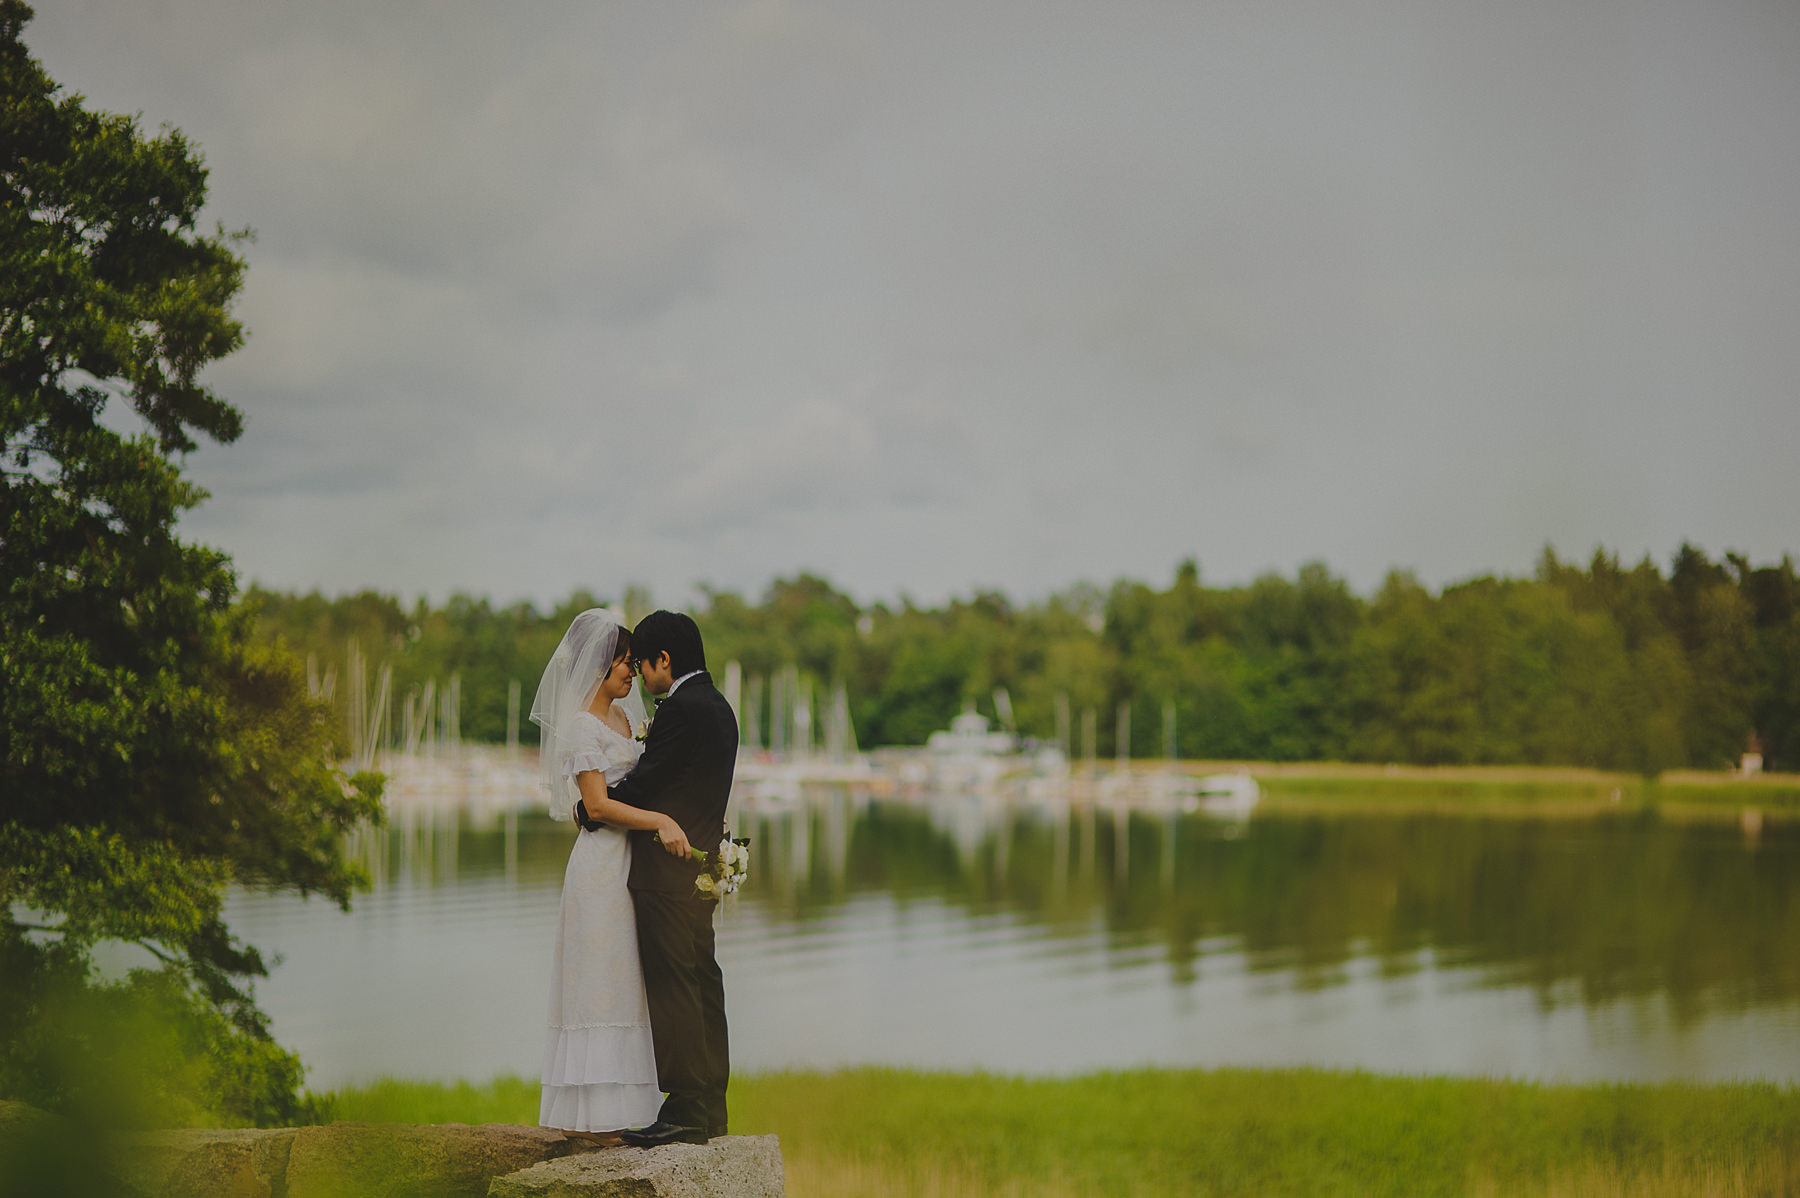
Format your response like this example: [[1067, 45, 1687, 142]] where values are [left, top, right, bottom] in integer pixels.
[[25, 0, 1800, 601]]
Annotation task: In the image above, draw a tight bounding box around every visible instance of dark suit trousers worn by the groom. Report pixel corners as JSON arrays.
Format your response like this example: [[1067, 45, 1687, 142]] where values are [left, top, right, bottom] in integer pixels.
[[632, 890, 731, 1135]]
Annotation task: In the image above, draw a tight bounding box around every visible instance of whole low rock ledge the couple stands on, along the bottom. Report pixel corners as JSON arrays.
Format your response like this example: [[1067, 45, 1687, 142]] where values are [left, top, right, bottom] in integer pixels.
[[0, 1103, 787, 1198]]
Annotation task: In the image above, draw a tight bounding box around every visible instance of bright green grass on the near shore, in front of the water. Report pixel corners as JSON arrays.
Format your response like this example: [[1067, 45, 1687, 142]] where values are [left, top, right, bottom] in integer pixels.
[[309, 1068, 1800, 1198]]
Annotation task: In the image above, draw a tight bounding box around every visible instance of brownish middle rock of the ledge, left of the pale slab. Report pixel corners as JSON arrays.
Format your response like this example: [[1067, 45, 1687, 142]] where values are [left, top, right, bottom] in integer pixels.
[[286, 1122, 572, 1198]]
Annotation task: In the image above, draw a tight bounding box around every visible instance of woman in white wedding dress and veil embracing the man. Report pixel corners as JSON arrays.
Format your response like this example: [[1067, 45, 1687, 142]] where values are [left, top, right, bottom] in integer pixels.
[[531, 608, 688, 1146]]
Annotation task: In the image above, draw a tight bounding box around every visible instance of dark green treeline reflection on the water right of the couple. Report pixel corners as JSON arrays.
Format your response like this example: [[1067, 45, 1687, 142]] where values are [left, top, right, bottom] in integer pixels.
[[745, 793, 1800, 1018]]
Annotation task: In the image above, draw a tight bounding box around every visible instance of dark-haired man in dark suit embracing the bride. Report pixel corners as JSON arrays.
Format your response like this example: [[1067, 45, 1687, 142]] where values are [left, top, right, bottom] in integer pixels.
[[578, 612, 738, 1148]]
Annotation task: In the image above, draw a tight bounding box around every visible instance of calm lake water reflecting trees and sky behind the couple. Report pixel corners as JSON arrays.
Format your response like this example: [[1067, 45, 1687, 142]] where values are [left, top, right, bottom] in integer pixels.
[[227, 793, 1800, 1086]]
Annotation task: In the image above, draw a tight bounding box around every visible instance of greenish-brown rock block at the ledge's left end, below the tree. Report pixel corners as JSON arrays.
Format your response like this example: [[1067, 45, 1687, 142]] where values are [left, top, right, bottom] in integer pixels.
[[112, 1128, 295, 1198]]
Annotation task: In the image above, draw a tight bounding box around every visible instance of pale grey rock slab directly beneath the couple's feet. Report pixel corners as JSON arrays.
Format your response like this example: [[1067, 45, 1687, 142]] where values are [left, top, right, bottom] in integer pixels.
[[488, 1135, 787, 1198]]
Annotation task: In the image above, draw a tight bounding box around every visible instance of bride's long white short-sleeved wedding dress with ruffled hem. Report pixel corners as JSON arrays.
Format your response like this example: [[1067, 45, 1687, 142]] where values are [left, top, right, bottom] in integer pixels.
[[538, 711, 662, 1131]]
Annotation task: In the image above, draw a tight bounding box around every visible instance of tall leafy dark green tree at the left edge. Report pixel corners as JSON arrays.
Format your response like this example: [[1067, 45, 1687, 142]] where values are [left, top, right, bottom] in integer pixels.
[[0, 0, 380, 1121]]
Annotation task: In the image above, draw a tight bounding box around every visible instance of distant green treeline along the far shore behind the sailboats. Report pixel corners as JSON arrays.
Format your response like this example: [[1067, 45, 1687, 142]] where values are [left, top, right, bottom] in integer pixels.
[[248, 545, 1800, 773]]
